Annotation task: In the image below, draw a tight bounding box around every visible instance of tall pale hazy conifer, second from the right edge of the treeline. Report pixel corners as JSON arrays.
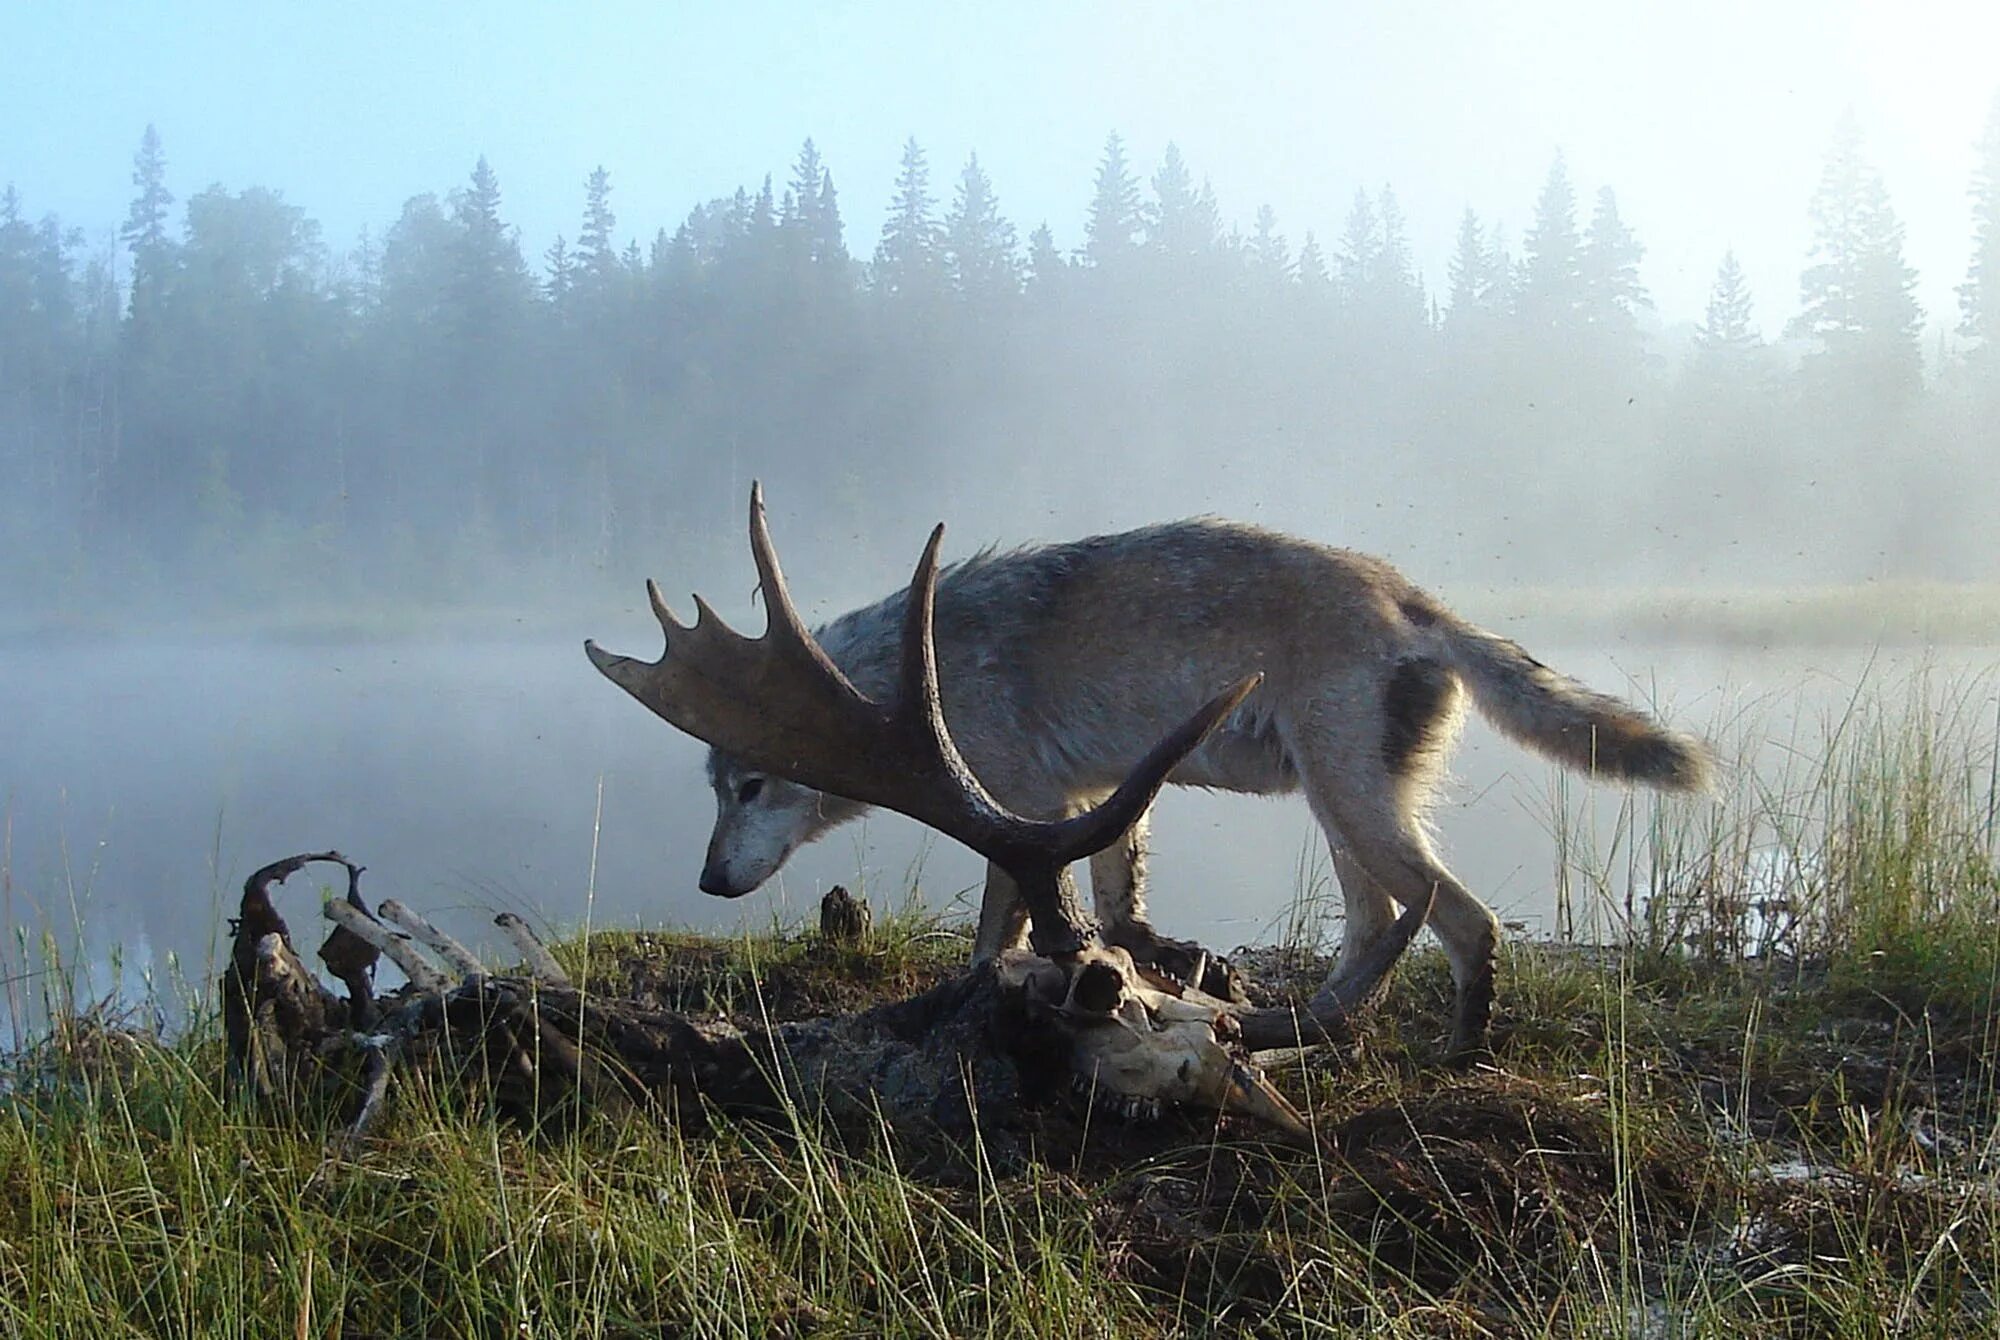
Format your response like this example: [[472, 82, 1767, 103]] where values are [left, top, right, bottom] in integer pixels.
[[1786, 114, 1924, 404]]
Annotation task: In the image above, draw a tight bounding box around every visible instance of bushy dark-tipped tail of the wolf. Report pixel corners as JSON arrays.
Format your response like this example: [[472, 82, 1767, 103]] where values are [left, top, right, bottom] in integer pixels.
[[1440, 620, 1714, 790]]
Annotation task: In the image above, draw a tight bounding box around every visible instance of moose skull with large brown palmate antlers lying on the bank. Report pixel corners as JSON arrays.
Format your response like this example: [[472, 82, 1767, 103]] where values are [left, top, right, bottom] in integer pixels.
[[584, 484, 1430, 1132]]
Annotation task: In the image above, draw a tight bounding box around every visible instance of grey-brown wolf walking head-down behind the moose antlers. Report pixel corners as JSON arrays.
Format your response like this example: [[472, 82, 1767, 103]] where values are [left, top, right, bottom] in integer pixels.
[[700, 518, 1712, 1056]]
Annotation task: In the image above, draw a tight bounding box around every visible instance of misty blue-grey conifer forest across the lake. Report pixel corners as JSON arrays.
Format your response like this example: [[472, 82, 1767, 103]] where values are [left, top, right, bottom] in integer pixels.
[[0, 102, 2000, 606]]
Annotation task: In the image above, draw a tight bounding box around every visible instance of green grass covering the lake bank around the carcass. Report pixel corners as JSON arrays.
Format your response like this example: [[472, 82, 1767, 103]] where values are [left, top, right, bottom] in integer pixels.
[[0, 678, 2000, 1338]]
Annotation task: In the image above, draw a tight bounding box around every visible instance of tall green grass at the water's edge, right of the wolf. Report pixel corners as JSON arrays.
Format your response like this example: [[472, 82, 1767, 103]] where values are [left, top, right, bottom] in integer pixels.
[[1624, 670, 2000, 1010]]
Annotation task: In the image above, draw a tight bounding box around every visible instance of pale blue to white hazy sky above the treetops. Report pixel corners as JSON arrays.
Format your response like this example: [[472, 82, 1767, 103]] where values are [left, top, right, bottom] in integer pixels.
[[0, 0, 2000, 334]]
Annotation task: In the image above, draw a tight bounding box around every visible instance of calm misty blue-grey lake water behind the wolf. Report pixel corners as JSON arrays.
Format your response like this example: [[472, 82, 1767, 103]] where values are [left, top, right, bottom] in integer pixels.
[[0, 628, 2000, 1040]]
